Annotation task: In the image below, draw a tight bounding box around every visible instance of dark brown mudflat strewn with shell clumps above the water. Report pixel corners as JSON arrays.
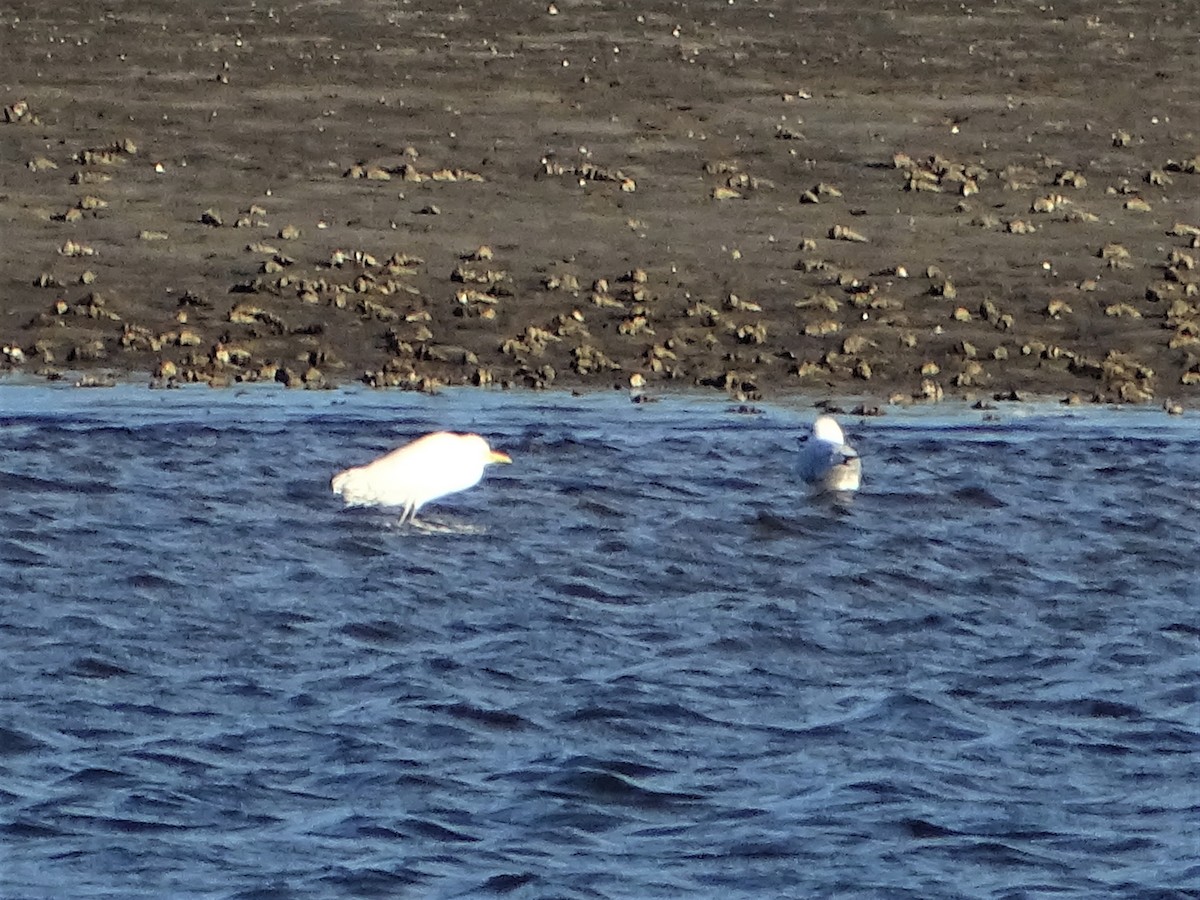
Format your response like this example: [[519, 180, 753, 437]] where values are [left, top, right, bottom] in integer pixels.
[[0, 0, 1200, 404]]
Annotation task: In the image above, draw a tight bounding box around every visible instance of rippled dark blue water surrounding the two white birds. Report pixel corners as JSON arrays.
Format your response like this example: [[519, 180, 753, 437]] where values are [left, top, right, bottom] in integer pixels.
[[0, 386, 1200, 900]]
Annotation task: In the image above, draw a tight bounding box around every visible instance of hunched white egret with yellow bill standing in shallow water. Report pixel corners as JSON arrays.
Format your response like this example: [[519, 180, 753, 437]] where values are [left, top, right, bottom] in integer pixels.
[[331, 431, 512, 522]]
